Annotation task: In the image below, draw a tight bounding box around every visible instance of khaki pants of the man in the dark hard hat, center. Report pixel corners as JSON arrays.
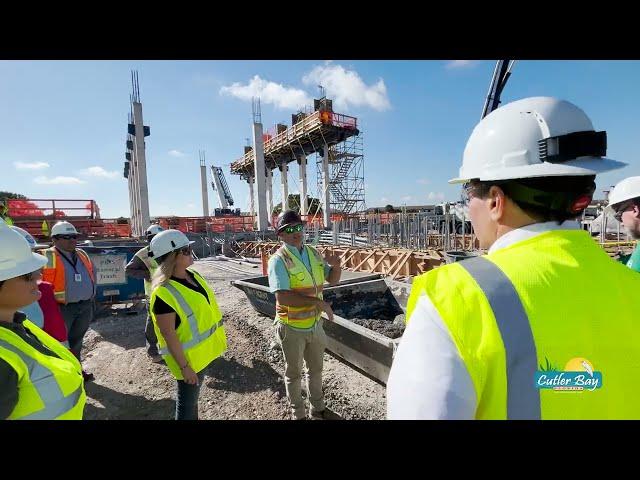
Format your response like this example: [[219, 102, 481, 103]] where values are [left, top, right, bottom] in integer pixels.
[[276, 319, 327, 419]]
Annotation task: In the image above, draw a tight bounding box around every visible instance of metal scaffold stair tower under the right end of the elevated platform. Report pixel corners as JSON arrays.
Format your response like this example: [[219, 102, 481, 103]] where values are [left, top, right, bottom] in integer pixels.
[[316, 133, 367, 217]]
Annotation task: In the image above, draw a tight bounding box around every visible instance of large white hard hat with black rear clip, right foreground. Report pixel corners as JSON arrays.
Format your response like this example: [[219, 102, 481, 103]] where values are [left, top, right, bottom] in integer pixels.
[[449, 97, 626, 183]]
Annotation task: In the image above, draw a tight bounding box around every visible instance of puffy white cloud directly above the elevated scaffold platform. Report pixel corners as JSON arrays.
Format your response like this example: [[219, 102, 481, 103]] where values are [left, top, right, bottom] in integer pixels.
[[302, 62, 391, 111]]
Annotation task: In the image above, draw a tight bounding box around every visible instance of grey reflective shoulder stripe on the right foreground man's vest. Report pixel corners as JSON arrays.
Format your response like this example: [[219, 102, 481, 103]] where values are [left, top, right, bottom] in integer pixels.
[[459, 257, 541, 420]]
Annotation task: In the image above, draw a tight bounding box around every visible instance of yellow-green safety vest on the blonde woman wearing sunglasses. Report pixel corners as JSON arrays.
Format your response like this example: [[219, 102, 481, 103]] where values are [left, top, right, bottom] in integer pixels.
[[149, 269, 227, 380]]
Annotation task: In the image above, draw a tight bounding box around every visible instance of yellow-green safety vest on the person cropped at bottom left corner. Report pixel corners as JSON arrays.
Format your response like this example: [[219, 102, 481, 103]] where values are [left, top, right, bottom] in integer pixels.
[[0, 320, 87, 420]]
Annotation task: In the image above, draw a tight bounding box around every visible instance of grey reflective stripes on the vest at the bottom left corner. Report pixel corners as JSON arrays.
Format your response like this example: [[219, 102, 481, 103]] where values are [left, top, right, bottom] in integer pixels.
[[0, 340, 82, 420]]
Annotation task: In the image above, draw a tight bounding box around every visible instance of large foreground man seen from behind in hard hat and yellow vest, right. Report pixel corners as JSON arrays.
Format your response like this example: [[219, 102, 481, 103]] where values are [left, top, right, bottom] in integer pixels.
[[387, 97, 640, 419]]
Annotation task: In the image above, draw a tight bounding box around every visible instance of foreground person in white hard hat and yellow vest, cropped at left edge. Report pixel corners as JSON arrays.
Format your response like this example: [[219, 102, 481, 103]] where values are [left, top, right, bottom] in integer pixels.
[[0, 224, 86, 420]]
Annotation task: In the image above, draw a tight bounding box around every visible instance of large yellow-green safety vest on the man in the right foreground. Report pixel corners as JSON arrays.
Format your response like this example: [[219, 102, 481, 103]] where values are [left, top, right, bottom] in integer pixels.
[[407, 230, 640, 419]]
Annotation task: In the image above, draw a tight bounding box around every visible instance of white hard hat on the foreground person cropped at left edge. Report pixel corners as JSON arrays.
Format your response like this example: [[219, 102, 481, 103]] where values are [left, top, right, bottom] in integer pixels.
[[0, 225, 47, 281]]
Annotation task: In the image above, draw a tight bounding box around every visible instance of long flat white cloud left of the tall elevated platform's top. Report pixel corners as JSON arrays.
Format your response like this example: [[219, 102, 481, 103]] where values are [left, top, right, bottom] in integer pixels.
[[220, 75, 311, 110]]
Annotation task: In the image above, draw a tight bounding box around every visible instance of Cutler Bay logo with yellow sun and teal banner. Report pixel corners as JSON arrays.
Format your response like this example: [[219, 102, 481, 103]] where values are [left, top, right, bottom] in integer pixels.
[[534, 357, 602, 391]]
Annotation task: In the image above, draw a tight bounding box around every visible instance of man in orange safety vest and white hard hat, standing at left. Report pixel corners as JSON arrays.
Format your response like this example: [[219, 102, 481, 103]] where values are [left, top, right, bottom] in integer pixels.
[[42, 221, 96, 382]]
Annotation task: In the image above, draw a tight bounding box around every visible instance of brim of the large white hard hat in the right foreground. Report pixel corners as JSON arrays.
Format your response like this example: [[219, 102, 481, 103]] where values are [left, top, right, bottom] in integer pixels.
[[449, 157, 627, 184]]
